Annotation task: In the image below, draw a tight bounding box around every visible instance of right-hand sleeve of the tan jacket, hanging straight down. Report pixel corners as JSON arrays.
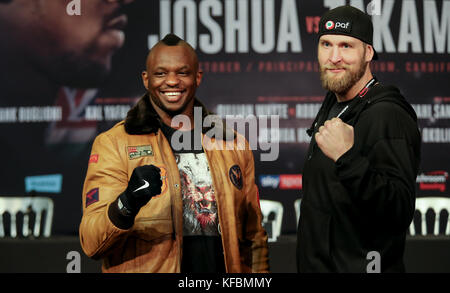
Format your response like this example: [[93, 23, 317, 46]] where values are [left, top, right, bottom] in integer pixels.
[[242, 145, 269, 273]]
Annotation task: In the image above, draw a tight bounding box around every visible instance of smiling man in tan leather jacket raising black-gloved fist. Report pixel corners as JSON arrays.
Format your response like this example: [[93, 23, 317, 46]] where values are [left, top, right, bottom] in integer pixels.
[[80, 34, 269, 273]]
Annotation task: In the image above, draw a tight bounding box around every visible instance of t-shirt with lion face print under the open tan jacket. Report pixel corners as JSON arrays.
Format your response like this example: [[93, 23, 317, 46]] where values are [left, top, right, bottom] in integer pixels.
[[161, 124, 225, 273]]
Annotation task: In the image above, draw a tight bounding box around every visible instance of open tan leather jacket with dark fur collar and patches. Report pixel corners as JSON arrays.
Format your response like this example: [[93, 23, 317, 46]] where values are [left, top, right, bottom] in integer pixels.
[[79, 95, 269, 273]]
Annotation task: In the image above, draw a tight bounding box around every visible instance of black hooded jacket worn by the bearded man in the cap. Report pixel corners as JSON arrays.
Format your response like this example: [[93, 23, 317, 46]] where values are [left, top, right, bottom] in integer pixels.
[[297, 84, 421, 273]]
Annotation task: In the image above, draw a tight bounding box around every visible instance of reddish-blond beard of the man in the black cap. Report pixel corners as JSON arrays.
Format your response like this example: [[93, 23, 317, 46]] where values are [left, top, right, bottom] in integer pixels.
[[320, 50, 369, 95]]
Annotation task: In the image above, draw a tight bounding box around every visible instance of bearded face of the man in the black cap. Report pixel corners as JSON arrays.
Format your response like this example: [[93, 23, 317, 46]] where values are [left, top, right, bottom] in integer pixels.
[[318, 35, 373, 95]]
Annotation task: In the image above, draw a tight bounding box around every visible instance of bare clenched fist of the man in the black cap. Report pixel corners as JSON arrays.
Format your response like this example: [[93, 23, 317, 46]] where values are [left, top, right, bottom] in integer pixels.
[[315, 118, 354, 162]]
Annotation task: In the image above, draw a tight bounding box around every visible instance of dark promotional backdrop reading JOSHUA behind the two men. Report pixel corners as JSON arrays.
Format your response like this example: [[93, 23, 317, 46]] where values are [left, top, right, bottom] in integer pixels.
[[0, 0, 450, 234]]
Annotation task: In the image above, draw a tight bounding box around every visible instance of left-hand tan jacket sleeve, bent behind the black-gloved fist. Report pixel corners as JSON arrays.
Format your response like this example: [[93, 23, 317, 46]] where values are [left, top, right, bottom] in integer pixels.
[[79, 133, 128, 258]]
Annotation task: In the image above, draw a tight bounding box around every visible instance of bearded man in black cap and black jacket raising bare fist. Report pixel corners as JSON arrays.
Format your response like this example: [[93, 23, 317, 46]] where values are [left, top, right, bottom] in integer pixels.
[[297, 6, 421, 272]]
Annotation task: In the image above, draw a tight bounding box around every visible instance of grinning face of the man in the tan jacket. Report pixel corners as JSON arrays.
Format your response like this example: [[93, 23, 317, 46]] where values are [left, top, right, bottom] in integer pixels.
[[142, 42, 202, 119]]
